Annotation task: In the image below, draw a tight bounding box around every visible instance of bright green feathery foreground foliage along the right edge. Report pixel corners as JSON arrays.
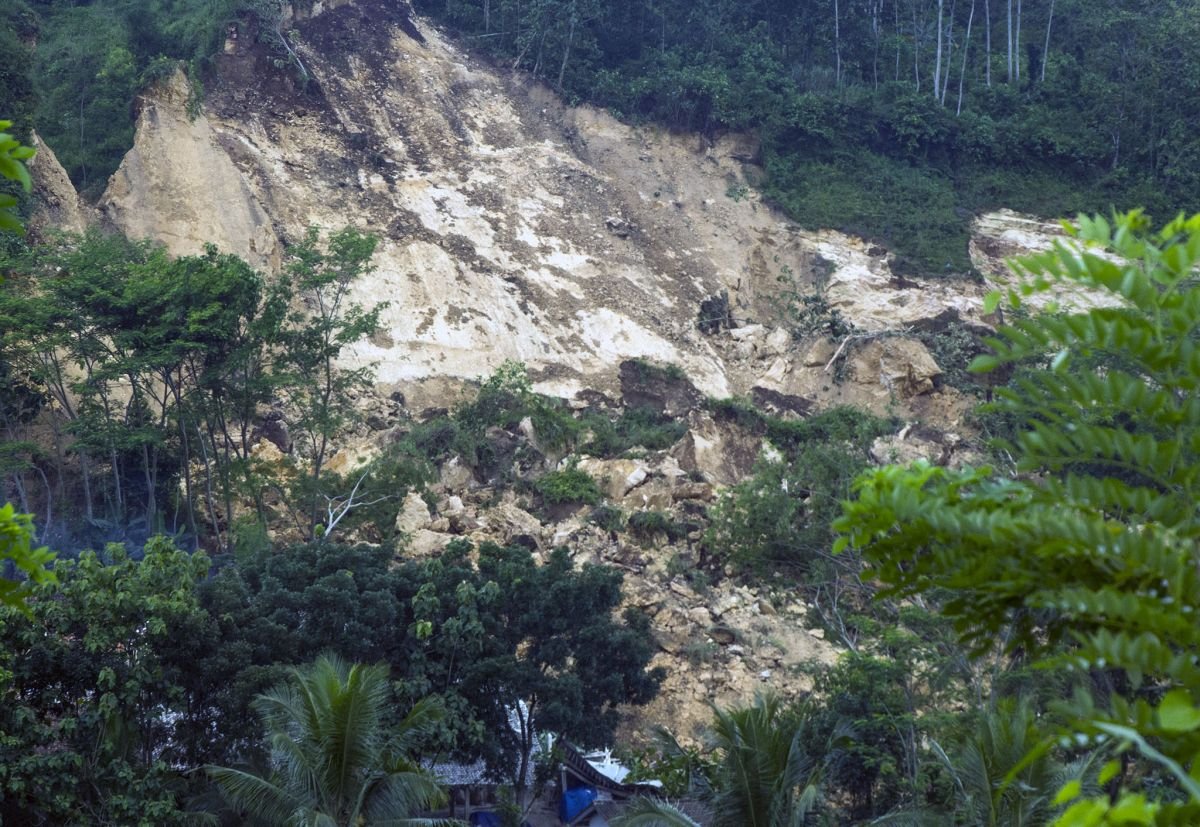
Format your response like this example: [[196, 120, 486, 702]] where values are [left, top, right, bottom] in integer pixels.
[[838, 212, 1200, 825]]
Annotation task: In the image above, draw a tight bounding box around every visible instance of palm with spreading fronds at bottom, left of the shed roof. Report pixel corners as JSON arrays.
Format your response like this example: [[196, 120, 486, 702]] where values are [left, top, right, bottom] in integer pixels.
[[208, 655, 457, 827]]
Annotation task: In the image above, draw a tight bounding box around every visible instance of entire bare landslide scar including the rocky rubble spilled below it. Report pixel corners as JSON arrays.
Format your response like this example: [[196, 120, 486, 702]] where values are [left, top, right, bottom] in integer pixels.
[[21, 0, 1089, 735]]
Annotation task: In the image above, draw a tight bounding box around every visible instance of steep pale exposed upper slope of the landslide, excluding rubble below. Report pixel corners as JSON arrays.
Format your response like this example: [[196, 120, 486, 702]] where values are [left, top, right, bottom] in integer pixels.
[[84, 0, 1075, 403]]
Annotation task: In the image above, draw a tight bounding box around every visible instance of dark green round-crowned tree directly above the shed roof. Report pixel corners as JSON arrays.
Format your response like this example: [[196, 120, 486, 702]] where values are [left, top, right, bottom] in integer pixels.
[[407, 541, 662, 791]]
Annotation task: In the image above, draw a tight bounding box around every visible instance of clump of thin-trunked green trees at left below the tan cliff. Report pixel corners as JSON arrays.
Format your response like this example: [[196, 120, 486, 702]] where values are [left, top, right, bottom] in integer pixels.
[[0, 230, 288, 549]]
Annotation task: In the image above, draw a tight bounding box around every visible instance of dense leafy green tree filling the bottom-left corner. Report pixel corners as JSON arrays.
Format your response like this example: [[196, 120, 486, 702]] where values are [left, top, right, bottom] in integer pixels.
[[0, 538, 212, 825]]
